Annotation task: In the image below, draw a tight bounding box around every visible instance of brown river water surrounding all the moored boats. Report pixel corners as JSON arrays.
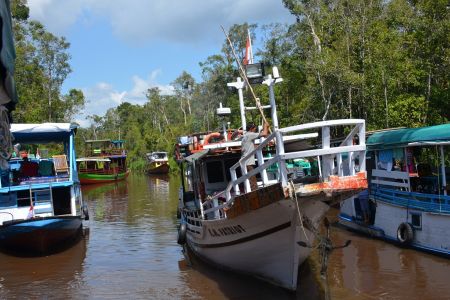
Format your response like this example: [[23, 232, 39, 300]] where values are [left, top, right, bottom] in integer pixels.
[[0, 175, 450, 299]]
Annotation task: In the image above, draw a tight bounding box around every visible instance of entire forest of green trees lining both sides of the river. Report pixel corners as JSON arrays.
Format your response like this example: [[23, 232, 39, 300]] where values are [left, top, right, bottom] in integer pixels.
[[7, 0, 450, 170]]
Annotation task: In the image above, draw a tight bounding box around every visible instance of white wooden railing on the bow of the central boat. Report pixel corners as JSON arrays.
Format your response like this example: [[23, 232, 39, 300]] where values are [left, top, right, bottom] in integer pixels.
[[201, 119, 366, 219]]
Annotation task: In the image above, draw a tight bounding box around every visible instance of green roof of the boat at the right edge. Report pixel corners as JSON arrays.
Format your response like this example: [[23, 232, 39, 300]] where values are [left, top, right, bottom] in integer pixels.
[[366, 123, 450, 150]]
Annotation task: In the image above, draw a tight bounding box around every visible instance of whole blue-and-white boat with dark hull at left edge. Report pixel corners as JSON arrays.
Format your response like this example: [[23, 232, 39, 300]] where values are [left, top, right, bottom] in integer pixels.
[[0, 123, 88, 254]]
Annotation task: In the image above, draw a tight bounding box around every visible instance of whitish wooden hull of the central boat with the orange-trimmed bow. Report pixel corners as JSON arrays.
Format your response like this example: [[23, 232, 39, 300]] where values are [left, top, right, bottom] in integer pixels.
[[187, 199, 329, 290]]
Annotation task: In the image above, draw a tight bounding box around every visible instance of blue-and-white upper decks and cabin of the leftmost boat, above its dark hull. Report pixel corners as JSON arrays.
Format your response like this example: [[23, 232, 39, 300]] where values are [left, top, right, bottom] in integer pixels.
[[0, 123, 81, 225]]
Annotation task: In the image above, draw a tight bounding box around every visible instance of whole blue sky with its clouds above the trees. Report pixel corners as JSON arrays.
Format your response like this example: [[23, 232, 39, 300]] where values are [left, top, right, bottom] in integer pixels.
[[28, 0, 294, 126]]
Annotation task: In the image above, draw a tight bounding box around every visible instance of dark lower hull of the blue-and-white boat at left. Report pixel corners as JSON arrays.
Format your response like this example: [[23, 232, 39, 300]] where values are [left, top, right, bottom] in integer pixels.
[[0, 216, 82, 255]]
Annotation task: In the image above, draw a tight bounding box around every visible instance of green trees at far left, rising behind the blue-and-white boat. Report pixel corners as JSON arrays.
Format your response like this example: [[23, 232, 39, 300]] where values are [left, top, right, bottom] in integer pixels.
[[11, 0, 84, 123]]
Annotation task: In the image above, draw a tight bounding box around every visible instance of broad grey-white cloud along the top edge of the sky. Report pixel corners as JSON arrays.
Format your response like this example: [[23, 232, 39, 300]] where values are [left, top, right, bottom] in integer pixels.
[[28, 0, 293, 44]]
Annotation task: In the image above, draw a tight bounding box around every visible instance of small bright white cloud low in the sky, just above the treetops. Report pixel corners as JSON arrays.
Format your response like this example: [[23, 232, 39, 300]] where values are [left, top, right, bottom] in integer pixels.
[[76, 70, 174, 127]]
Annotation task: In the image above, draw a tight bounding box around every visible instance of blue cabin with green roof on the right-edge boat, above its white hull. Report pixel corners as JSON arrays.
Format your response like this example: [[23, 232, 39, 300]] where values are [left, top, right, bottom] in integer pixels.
[[343, 124, 450, 225]]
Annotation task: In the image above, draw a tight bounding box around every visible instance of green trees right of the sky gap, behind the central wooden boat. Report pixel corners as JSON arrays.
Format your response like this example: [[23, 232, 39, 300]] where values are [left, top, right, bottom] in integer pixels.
[[79, 0, 450, 167]]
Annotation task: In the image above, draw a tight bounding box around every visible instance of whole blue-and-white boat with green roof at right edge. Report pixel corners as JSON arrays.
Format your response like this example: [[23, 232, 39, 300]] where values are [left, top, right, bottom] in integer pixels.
[[339, 124, 450, 256]]
